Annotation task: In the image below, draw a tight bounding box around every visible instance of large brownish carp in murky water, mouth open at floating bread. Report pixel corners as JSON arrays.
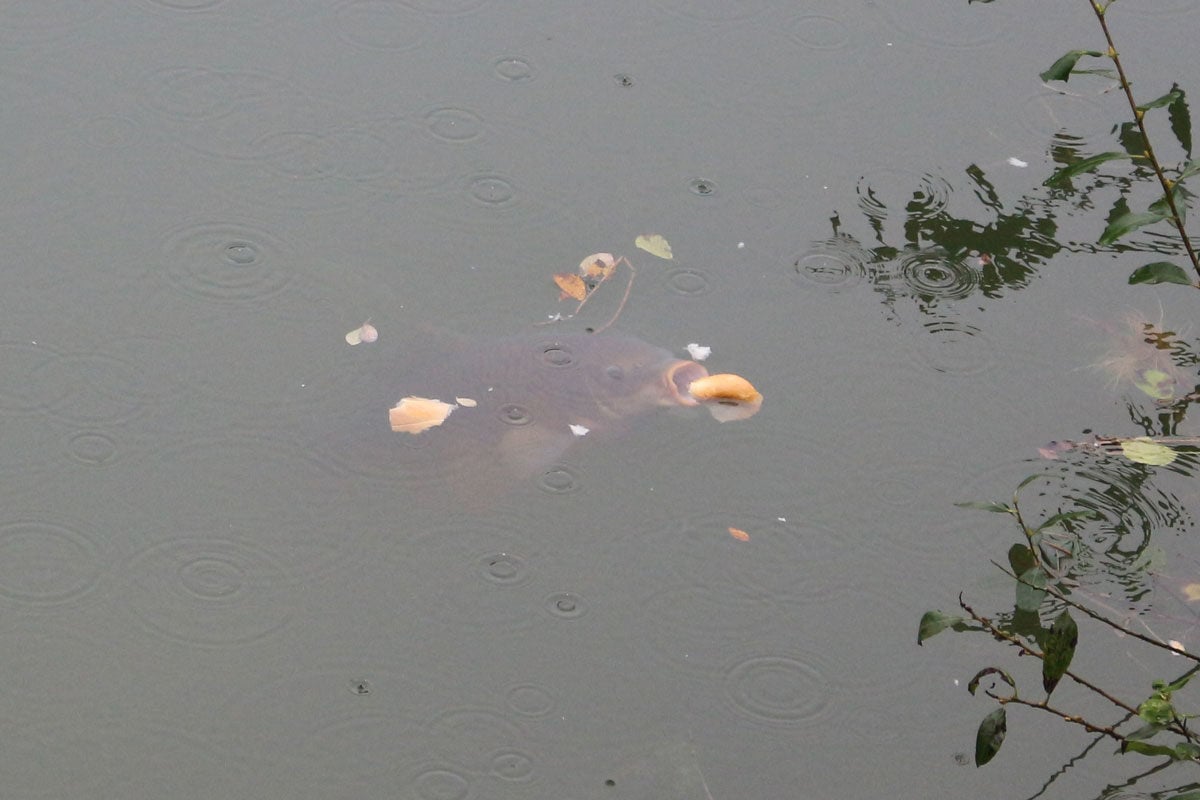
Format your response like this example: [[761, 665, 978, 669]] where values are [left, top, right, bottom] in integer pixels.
[[319, 333, 761, 500]]
